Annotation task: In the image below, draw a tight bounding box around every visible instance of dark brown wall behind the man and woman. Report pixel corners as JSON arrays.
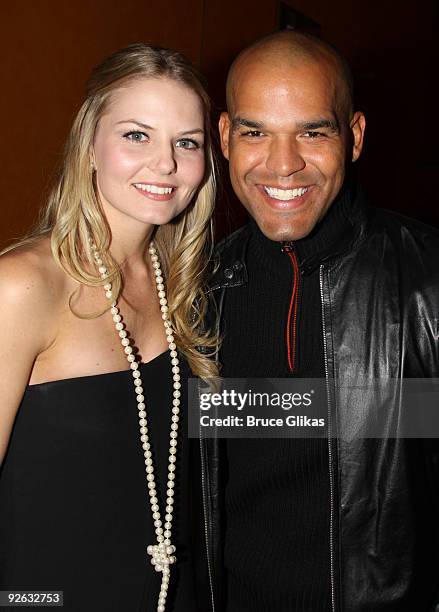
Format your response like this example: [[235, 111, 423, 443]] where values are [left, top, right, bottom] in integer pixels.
[[0, 0, 439, 247]]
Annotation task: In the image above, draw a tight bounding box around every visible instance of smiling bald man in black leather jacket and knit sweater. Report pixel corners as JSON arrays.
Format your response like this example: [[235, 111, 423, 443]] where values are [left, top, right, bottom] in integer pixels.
[[201, 32, 439, 612]]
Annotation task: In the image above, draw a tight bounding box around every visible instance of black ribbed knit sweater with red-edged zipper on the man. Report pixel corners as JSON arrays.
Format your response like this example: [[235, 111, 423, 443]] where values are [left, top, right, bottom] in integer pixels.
[[220, 189, 352, 612]]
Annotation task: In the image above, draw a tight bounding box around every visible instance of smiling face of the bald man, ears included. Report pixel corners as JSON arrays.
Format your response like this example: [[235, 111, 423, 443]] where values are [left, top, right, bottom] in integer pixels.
[[220, 62, 365, 241]]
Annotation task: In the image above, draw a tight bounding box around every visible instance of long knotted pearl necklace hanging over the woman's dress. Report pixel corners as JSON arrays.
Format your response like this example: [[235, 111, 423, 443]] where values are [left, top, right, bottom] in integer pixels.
[[90, 240, 181, 612]]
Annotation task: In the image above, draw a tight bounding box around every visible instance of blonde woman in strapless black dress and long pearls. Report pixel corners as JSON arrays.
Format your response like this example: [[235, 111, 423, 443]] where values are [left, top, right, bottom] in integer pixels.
[[0, 44, 216, 612]]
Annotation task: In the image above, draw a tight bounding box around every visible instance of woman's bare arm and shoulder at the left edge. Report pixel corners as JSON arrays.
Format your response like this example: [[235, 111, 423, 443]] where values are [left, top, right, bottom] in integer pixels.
[[0, 249, 55, 463]]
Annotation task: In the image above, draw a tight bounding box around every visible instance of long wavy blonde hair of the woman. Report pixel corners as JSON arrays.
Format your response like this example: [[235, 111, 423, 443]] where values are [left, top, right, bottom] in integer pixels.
[[2, 43, 217, 379]]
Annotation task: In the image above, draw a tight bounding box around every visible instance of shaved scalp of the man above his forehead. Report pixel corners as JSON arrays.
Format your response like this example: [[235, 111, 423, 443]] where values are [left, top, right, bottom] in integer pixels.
[[226, 31, 353, 120]]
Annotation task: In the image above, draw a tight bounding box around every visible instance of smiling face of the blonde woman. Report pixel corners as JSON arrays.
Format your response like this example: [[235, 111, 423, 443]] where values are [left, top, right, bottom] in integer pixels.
[[92, 78, 205, 227]]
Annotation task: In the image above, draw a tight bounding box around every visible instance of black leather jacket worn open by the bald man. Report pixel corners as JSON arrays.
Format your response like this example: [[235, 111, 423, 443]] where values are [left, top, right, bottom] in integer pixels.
[[200, 196, 439, 612]]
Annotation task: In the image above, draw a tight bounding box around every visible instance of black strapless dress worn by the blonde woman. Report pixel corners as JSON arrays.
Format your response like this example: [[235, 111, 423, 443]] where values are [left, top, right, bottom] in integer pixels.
[[0, 353, 197, 612]]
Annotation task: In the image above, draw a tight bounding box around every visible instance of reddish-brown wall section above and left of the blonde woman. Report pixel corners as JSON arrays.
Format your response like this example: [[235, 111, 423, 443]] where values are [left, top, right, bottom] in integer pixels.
[[0, 0, 203, 248]]
